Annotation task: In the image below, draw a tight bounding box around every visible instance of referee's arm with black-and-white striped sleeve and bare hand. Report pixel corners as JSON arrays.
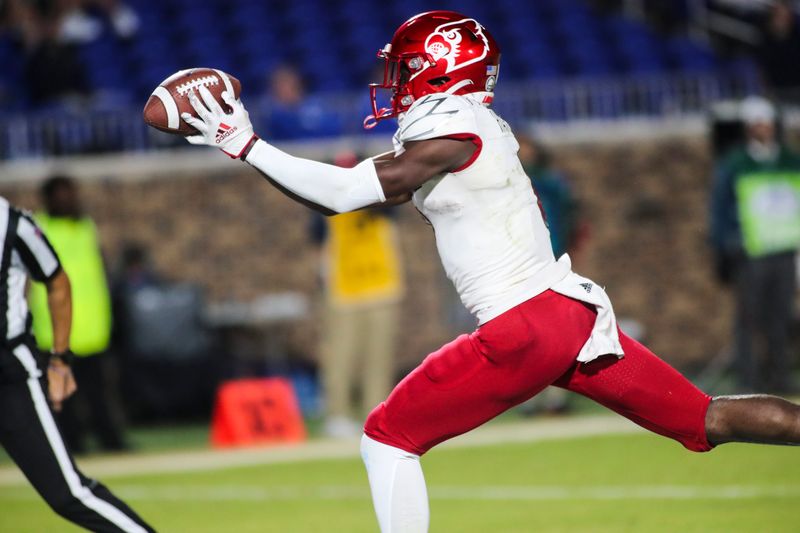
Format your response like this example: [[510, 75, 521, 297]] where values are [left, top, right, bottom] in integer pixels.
[[14, 213, 77, 411]]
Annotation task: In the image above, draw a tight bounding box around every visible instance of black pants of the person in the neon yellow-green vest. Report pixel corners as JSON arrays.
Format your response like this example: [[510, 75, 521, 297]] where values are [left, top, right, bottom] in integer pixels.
[[57, 354, 126, 454]]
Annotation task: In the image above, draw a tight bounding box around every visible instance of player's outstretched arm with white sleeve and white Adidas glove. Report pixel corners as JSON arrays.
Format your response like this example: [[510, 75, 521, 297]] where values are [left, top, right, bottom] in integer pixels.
[[182, 87, 475, 214]]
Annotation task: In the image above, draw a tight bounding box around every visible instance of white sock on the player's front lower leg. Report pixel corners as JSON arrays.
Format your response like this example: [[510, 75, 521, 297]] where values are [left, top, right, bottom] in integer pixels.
[[361, 435, 429, 533]]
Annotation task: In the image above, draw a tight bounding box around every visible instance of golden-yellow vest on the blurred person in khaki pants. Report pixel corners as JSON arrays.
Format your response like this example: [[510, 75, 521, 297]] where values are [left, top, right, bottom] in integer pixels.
[[328, 210, 403, 305]]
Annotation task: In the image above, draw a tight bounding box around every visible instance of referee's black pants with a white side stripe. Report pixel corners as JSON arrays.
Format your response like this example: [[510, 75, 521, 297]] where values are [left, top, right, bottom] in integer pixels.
[[0, 344, 154, 533]]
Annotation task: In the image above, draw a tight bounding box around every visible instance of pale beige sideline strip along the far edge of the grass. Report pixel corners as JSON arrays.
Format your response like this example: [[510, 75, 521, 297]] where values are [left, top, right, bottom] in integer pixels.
[[0, 415, 642, 487]]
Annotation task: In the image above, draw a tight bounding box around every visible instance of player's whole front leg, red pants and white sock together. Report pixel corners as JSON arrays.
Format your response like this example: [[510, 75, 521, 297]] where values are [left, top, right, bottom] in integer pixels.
[[362, 291, 596, 533]]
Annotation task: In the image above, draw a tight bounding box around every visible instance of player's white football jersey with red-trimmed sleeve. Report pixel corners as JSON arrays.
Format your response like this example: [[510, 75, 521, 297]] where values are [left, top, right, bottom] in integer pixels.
[[394, 94, 571, 324]]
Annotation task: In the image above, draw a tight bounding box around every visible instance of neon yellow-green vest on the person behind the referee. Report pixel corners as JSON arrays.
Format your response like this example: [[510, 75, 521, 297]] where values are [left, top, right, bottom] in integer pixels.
[[28, 213, 111, 355]]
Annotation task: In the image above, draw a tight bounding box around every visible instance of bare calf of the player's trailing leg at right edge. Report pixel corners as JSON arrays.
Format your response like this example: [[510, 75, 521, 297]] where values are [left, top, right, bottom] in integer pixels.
[[706, 394, 800, 446]]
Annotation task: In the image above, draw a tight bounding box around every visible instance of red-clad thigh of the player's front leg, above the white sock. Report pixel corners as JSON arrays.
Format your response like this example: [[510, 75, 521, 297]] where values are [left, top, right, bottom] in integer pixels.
[[364, 291, 596, 455]]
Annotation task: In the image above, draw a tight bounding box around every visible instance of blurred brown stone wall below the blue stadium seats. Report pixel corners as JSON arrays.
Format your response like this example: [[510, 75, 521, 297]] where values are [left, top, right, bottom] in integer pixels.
[[0, 134, 756, 366]]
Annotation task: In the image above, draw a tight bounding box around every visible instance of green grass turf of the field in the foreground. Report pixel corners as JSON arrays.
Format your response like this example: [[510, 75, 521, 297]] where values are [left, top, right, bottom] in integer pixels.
[[0, 434, 800, 533]]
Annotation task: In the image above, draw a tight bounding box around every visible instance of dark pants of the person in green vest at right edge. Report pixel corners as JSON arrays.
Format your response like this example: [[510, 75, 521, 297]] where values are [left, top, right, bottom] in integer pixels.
[[734, 253, 797, 393]]
